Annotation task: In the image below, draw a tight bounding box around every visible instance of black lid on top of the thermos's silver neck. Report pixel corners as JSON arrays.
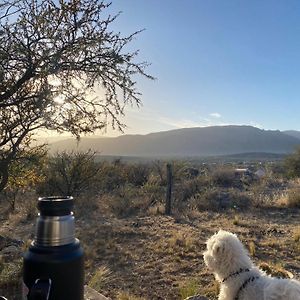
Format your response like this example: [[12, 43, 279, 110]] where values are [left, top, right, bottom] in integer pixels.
[[38, 196, 74, 216]]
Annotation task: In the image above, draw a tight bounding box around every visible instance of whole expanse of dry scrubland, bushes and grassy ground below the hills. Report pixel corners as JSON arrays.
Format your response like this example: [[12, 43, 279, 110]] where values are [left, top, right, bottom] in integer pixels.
[[0, 152, 300, 300]]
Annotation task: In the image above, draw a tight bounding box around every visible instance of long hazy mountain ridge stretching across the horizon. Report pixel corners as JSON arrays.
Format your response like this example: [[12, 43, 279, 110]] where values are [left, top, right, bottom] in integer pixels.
[[46, 125, 300, 157]]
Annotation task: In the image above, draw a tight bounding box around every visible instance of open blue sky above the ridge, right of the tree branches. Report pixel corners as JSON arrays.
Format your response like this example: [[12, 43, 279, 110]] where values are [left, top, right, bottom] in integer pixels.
[[45, 0, 300, 136]]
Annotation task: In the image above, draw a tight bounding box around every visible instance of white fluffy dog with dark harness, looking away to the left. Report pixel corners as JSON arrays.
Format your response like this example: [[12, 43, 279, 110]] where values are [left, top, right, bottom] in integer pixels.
[[204, 230, 300, 300]]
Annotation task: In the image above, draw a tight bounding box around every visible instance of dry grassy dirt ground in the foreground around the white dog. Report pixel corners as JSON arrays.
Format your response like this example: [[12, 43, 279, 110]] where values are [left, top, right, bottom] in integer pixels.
[[0, 208, 300, 300]]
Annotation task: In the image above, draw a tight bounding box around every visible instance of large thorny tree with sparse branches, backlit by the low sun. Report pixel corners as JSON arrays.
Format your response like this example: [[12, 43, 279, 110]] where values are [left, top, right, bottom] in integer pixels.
[[0, 0, 153, 191]]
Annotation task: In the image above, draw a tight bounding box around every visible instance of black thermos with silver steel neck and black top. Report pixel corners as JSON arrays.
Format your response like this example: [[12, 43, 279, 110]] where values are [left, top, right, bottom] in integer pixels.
[[23, 197, 84, 300]]
